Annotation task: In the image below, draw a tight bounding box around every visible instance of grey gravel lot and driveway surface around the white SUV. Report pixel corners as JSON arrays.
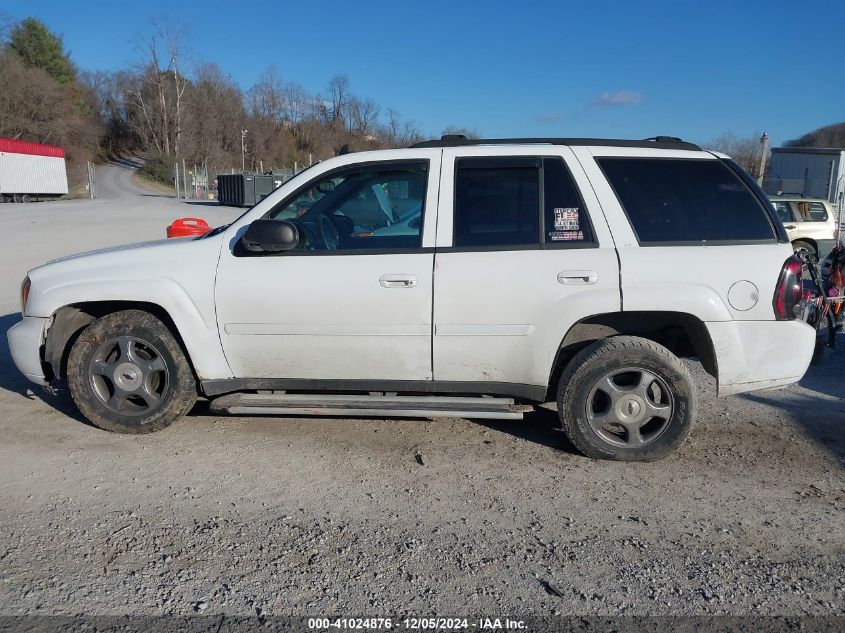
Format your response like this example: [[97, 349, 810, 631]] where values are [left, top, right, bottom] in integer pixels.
[[0, 167, 845, 616]]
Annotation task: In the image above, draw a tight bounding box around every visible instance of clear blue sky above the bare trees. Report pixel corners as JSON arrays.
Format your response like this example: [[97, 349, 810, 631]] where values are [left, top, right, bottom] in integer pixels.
[[0, 0, 845, 146]]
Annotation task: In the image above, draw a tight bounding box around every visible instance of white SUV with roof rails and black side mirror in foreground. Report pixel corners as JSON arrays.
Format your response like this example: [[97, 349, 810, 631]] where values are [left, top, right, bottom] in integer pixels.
[[8, 137, 815, 460]]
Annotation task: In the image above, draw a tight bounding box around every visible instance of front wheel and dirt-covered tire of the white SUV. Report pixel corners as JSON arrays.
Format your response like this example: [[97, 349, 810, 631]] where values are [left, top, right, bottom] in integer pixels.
[[67, 310, 197, 434]]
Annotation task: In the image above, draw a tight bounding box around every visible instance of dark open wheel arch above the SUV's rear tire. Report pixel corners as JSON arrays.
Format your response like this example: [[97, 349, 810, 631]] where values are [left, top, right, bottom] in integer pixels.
[[548, 311, 718, 395]]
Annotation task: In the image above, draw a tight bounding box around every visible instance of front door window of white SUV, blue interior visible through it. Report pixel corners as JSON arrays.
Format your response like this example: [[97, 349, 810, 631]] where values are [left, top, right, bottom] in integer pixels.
[[267, 161, 428, 251]]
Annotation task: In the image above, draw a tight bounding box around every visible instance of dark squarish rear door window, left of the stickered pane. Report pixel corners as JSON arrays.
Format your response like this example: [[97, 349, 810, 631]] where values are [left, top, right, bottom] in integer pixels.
[[454, 157, 540, 247]]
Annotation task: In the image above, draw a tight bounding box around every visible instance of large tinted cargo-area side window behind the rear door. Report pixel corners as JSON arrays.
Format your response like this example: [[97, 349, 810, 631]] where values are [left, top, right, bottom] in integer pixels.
[[597, 157, 775, 245]]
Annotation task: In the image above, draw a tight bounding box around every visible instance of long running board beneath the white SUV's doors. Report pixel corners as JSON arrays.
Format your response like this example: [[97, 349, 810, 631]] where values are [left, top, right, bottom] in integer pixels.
[[211, 393, 534, 420]]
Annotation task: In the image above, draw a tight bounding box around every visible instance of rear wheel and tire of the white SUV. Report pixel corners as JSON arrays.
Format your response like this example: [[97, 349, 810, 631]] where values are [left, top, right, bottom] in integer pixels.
[[557, 336, 696, 462]]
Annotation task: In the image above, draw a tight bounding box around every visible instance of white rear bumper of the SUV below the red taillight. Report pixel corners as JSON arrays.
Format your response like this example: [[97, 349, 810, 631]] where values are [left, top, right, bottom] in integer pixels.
[[705, 320, 816, 396]]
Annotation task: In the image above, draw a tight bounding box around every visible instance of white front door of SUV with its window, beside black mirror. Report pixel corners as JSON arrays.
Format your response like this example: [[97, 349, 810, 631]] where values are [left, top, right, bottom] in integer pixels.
[[216, 150, 440, 380]]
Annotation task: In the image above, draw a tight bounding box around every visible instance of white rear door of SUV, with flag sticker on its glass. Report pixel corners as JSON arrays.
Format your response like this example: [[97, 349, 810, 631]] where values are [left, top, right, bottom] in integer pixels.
[[433, 147, 619, 393]]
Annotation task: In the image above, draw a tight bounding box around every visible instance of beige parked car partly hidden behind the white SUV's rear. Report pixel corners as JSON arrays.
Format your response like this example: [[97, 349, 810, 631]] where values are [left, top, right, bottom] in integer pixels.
[[770, 196, 839, 256]]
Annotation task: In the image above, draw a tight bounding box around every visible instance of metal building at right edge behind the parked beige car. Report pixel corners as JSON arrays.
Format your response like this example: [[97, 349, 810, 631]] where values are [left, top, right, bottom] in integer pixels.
[[763, 147, 845, 202]]
